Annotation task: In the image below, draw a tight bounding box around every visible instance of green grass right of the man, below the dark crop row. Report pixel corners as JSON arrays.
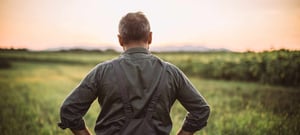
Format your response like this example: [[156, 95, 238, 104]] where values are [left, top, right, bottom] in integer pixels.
[[185, 78, 300, 135]]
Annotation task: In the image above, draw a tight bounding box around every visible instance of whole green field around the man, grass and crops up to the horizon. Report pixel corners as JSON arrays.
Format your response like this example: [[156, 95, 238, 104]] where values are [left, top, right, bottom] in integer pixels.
[[0, 51, 300, 135]]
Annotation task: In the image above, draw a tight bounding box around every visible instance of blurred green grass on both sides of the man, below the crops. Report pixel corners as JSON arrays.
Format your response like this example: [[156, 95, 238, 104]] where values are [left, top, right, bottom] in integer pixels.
[[0, 54, 300, 135]]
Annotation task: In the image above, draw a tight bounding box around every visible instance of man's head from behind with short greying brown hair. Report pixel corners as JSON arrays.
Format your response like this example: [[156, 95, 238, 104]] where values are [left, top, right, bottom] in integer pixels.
[[118, 12, 152, 47]]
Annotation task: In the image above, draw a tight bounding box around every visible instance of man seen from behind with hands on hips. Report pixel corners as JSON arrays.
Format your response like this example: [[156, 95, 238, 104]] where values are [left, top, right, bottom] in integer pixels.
[[59, 12, 210, 135]]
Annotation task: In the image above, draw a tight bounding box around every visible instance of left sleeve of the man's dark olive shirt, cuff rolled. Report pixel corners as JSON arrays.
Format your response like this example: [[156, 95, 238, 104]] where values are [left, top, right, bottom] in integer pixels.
[[58, 67, 99, 130]]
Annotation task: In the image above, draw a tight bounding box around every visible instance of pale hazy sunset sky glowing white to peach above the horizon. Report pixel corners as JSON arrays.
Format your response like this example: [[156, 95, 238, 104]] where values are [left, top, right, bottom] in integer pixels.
[[0, 0, 300, 51]]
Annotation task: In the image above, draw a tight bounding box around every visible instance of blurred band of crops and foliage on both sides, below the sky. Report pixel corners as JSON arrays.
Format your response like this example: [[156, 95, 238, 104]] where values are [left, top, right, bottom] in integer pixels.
[[0, 50, 300, 87]]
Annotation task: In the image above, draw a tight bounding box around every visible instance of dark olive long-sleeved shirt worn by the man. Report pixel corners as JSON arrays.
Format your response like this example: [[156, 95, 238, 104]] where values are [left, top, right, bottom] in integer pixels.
[[59, 48, 210, 135]]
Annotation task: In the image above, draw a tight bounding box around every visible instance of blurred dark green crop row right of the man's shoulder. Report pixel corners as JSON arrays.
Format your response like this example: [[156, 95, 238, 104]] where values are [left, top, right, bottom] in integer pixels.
[[158, 50, 300, 86]]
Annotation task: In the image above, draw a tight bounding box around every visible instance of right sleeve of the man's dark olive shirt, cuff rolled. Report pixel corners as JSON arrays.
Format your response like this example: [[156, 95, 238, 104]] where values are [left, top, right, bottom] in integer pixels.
[[175, 65, 210, 132]]
